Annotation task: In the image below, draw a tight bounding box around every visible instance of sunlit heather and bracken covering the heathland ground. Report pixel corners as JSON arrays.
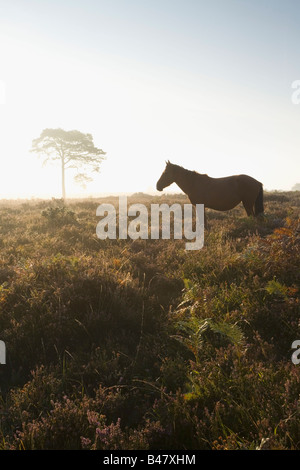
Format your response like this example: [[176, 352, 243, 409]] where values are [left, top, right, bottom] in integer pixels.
[[0, 192, 300, 450]]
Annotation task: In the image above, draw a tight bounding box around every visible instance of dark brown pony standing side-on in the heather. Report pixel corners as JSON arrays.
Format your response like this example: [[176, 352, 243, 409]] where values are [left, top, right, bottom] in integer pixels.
[[156, 161, 264, 216]]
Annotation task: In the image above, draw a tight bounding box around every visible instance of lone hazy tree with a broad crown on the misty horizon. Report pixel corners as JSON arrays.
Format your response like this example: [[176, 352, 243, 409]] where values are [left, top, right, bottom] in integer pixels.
[[31, 129, 105, 199]]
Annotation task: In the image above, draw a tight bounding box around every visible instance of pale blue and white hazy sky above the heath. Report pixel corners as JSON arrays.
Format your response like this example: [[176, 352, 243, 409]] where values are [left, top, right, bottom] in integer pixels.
[[0, 0, 300, 198]]
